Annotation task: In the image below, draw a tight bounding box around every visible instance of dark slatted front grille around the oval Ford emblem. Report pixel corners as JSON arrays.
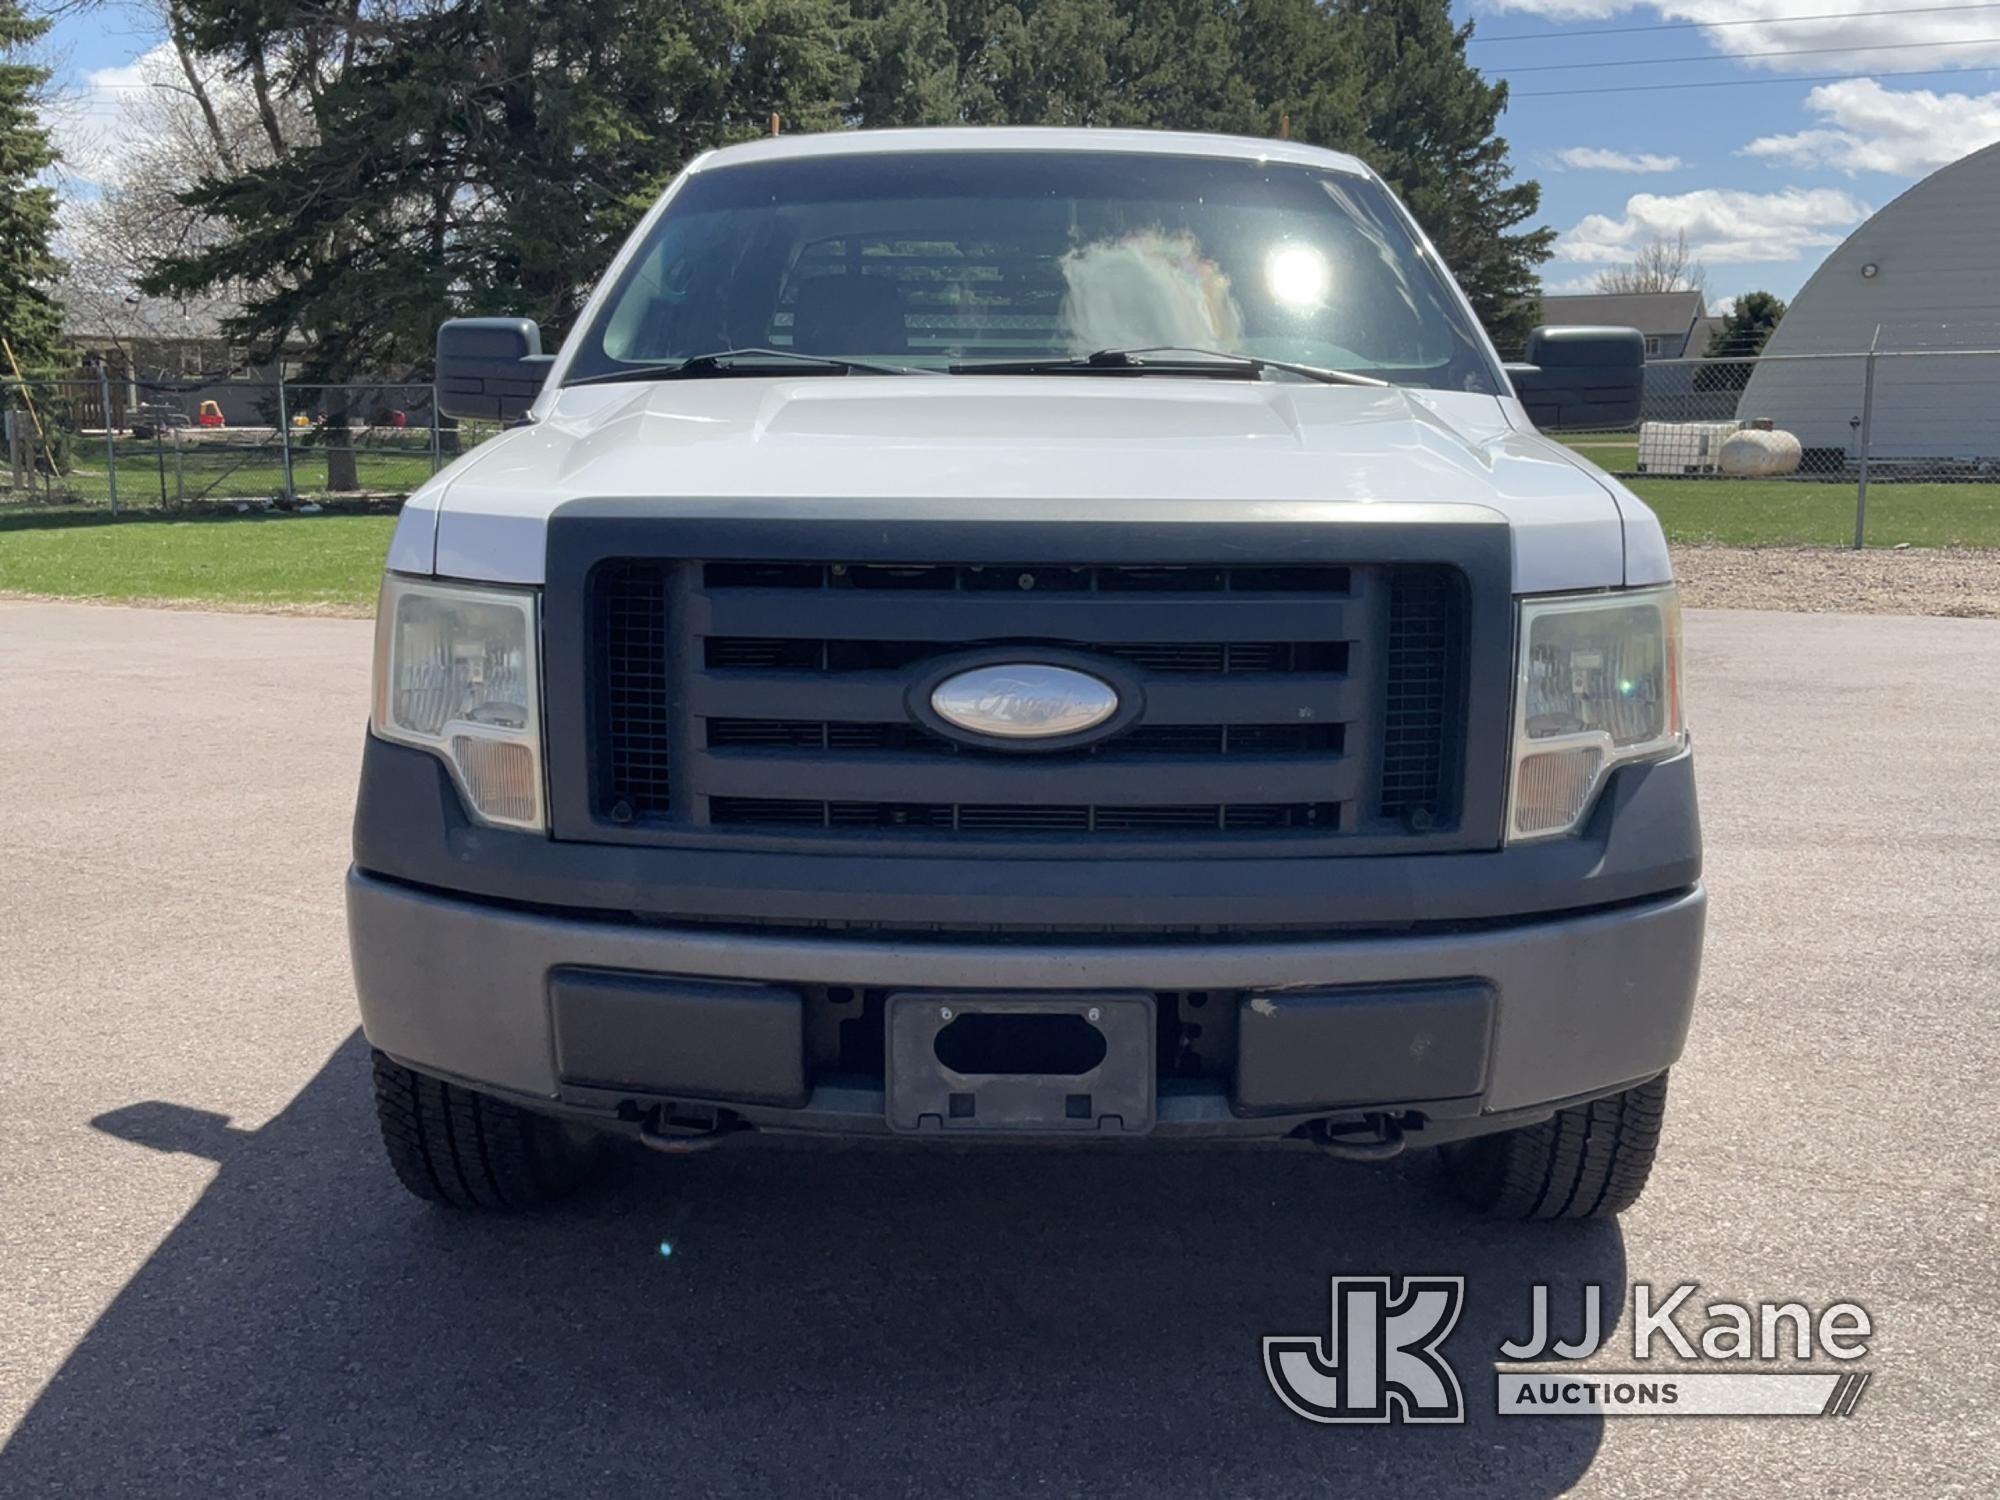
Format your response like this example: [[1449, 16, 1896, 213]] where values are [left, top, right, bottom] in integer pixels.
[[590, 560, 1464, 842]]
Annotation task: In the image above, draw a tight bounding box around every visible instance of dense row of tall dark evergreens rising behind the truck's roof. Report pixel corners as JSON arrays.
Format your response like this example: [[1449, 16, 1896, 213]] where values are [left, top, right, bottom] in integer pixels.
[[152, 0, 1552, 380]]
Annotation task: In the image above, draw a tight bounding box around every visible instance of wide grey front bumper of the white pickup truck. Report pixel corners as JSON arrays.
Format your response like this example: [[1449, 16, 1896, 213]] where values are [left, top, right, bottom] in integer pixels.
[[348, 870, 1706, 1142]]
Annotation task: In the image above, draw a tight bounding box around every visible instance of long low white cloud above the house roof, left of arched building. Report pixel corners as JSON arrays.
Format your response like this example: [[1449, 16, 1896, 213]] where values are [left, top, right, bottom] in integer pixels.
[[1556, 188, 1868, 266]]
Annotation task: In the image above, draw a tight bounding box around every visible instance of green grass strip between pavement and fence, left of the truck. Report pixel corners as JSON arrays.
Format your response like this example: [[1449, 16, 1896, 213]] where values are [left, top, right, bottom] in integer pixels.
[[0, 510, 396, 610]]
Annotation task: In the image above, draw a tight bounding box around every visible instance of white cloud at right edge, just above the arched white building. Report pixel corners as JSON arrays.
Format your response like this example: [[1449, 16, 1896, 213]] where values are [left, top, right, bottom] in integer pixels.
[[1738, 78, 2000, 178]]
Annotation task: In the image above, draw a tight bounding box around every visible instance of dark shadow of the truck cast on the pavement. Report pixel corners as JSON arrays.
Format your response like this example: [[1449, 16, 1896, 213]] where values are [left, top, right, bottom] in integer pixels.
[[0, 1036, 1624, 1496]]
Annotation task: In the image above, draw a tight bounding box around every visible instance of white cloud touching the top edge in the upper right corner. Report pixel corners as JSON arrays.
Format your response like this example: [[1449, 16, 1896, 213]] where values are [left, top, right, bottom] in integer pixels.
[[1474, 0, 2000, 80]]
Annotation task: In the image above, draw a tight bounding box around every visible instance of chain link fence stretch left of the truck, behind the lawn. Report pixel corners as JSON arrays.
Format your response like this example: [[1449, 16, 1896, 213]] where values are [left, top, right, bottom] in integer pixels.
[[0, 372, 498, 512]]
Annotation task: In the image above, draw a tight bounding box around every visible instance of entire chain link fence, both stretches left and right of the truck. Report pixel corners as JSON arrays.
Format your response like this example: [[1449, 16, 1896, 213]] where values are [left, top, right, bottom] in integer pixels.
[[0, 340, 2000, 546]]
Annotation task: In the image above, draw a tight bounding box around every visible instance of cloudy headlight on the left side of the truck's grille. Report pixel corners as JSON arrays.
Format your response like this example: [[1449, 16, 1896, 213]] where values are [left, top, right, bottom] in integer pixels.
[[370, 574, 544, 832]]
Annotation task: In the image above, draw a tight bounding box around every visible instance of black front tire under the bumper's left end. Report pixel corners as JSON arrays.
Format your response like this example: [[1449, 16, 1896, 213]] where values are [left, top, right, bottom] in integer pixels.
[[374, 1052, 596, 1210]]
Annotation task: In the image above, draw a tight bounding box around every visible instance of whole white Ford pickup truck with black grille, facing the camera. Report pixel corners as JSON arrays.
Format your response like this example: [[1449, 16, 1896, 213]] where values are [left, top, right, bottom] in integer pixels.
[[348, 130, 1704, 1218]]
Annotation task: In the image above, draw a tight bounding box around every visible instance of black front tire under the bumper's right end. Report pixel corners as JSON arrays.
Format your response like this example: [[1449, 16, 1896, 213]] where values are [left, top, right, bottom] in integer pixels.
[[1444, 1074, 1666, 1220]]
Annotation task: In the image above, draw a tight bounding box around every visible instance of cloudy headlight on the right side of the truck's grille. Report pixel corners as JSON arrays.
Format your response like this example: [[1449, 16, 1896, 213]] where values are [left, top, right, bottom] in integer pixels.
[[1508, 586, 1686, 842]]
